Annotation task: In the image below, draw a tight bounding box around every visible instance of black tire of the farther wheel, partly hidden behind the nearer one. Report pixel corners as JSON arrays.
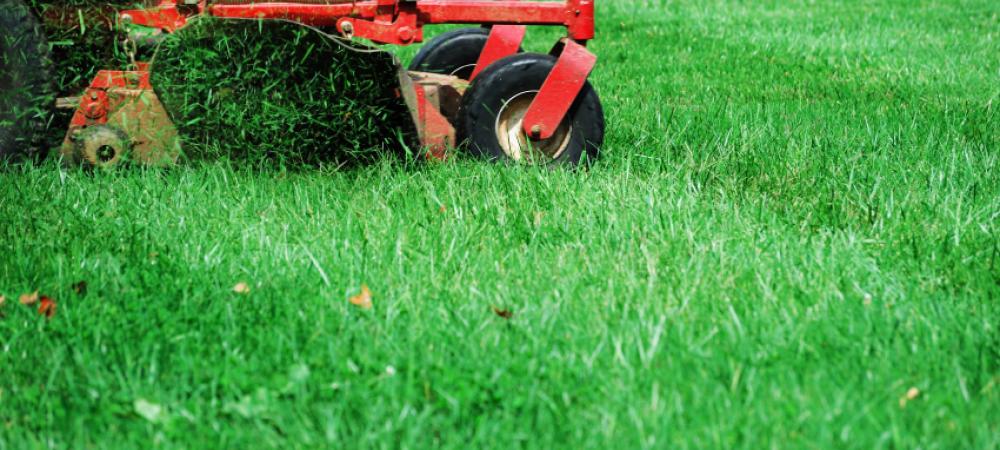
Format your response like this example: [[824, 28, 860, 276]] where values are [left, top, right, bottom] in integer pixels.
[[410, 28, 504, 80]]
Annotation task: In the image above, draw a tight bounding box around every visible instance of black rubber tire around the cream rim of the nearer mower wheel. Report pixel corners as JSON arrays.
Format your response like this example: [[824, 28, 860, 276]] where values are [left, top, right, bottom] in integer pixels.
[[456, 53, 605, 166]]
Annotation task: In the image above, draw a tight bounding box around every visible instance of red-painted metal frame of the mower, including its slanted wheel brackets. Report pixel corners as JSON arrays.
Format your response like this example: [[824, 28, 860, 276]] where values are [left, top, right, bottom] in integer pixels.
[[64, 0, 597, 163]]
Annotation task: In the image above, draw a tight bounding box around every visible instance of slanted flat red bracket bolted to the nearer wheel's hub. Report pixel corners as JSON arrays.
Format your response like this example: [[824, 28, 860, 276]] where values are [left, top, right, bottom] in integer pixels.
[[524, 39, 597, 140]]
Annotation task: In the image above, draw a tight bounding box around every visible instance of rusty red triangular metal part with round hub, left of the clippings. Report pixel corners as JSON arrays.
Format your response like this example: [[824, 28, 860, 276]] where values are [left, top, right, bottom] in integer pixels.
[[61, 65, 180, 167]]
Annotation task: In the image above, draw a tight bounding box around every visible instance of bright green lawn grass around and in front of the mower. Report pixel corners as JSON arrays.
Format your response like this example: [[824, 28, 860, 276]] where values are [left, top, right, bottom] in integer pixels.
[[0, 0, 1000, 449]]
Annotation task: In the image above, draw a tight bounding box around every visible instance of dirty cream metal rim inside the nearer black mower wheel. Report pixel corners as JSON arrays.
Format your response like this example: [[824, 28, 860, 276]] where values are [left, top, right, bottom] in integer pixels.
[[494, 91, 573, 164]]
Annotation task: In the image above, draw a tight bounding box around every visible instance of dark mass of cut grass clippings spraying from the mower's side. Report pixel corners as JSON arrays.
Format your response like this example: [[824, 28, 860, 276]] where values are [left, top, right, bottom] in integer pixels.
[[152, 18, 415, 164]]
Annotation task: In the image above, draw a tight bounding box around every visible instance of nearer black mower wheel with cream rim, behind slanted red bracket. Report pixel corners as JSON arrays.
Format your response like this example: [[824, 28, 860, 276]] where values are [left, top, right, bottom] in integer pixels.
[[456, 53, 604, 166]]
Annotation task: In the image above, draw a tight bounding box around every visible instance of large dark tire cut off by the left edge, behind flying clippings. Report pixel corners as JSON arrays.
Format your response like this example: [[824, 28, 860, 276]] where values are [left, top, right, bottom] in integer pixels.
[[0, 0, 55, 160]]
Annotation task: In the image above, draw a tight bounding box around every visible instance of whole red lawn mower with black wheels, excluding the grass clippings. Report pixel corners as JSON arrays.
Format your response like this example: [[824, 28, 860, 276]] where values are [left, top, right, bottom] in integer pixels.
[[0, 0, 604, 167]]
